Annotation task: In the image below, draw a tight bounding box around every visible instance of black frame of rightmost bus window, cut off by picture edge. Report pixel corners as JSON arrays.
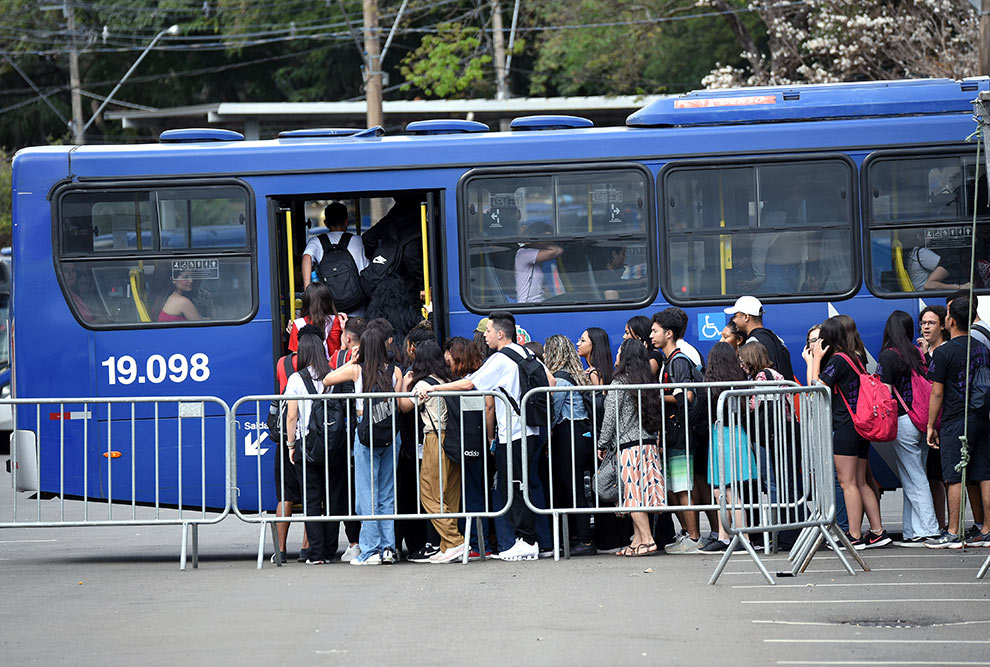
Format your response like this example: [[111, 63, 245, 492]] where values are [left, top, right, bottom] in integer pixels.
[[859, 148, 990, 299]]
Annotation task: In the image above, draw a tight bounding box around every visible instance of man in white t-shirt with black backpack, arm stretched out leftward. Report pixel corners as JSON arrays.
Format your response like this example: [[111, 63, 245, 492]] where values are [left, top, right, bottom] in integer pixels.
[[420, 310, 552, 560]]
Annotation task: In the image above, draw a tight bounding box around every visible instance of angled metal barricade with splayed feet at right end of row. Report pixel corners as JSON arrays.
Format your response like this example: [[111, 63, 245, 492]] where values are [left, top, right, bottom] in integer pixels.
[[710, 386, 868, 584]]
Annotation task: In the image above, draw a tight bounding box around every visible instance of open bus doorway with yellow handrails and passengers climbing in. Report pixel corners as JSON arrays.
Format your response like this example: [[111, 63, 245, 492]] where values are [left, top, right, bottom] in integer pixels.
[[271, 190, 446, 358]]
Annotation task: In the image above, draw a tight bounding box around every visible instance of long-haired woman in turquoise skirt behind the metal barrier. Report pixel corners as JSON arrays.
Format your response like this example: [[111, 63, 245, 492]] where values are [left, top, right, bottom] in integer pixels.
[[701, 341, 757, 553]]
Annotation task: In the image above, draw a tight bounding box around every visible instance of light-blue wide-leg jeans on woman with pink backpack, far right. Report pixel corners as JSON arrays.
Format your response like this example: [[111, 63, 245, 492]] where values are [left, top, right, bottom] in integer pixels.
[[891, 415, 939, 539]]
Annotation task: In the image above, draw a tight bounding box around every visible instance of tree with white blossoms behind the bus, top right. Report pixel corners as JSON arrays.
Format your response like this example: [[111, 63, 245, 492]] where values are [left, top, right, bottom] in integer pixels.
[[698, 0, 979, 88]]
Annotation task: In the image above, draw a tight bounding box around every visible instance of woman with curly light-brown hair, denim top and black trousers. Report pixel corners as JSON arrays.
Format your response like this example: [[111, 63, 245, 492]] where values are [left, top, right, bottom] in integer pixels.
[[543, 334, 596, 556]]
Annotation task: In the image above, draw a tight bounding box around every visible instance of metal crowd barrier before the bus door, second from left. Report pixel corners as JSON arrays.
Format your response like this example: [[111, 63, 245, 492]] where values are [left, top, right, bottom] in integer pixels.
[[230, 391, 515, 569]]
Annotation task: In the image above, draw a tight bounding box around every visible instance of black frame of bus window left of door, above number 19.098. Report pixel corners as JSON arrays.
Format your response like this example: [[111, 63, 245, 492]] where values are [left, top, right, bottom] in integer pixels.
[[49, 177, 261, 331]]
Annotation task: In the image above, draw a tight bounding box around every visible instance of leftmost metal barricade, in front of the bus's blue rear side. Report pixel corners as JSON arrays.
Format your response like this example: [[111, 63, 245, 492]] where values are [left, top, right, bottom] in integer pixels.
[[0, 396, 231, 570]]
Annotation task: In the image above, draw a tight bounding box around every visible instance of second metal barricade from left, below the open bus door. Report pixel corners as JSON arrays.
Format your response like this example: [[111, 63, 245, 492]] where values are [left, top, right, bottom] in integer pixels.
[[230, 391, 515, 569]]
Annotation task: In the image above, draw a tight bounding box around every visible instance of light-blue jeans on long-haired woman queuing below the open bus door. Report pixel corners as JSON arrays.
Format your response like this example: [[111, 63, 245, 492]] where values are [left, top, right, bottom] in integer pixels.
[[354, 432, 399, 560]]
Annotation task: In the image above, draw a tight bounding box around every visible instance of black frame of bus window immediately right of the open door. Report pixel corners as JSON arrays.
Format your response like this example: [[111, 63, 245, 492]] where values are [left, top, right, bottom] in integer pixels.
[[457, 161, 660, 315]]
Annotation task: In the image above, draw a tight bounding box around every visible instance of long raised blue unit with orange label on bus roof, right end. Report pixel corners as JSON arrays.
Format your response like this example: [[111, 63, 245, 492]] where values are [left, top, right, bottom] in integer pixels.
[[626, 77, 990, 127]]
